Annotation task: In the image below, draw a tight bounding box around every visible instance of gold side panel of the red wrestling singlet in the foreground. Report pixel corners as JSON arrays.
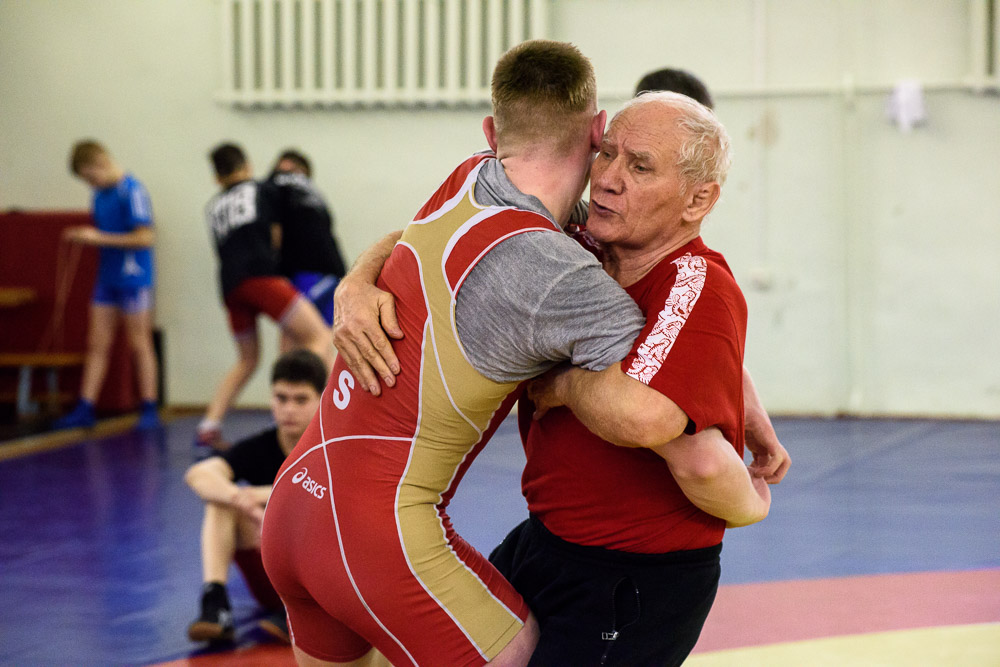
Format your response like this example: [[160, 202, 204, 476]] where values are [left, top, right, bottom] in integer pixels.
[[397, 193, 521, 659]]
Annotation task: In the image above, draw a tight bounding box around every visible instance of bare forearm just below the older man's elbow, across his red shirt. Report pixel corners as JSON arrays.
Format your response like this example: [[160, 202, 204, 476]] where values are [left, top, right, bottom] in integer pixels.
[[654, 429, 771, 527]]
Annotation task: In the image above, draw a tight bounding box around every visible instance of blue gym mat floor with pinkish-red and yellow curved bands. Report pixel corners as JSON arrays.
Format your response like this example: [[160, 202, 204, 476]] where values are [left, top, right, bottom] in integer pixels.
[[0, 412, 1000, 667]]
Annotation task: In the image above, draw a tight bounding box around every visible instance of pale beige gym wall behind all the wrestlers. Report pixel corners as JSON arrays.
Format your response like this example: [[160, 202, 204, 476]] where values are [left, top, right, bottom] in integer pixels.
[[0, 0, 1000, 417]]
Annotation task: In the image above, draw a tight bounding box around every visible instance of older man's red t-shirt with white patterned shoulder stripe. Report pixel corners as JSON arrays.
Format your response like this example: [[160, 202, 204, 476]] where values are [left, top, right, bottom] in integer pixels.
[[520, 238, 747, 553]]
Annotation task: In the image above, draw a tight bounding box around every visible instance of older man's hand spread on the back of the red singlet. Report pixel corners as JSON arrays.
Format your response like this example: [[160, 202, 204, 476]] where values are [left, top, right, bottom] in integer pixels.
[[333, 275, 403, 396]]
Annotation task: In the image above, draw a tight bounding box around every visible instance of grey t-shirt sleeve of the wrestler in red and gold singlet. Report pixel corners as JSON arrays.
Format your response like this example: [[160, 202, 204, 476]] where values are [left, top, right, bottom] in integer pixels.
[[455, 232, 645, 382]]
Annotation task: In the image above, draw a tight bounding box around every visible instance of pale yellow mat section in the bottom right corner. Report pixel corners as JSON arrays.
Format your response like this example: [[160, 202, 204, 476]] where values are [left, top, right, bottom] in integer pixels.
[[684, 623, 1000, 667]]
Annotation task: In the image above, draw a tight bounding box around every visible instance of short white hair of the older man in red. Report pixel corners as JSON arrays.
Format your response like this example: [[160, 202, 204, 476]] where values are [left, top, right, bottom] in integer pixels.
[[611, 91, 732, 189]]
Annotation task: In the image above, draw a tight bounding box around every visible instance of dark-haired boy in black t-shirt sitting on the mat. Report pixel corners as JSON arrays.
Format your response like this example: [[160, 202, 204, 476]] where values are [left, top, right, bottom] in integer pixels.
[[184, 350, 326, 642]]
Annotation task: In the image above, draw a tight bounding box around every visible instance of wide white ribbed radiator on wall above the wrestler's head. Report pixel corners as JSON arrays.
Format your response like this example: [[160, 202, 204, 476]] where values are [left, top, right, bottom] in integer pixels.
[[220, 0, 548, 107]]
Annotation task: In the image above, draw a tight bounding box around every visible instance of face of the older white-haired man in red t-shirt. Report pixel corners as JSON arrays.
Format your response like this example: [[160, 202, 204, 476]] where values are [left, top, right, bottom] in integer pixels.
[[587, 103, 685, 249]]
